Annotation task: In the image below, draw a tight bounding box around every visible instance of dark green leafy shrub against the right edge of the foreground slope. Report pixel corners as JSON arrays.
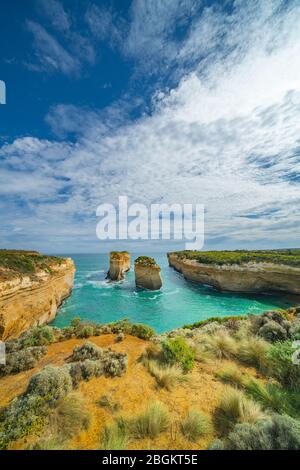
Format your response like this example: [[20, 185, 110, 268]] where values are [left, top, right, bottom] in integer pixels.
[[267, 341, 300, 391]]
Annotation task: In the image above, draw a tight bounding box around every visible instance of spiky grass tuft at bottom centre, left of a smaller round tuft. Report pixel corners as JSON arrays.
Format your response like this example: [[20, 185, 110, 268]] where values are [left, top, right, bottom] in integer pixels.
[[130, 402, 170, 439]]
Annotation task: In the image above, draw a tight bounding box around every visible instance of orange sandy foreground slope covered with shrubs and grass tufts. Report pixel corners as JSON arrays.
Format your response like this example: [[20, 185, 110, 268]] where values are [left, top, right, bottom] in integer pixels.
[[0, 308, 300, 450]]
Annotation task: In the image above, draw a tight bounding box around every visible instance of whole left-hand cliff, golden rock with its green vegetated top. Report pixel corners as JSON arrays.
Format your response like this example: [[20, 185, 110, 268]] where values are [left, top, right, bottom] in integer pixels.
[[0, 250, 75, 340]]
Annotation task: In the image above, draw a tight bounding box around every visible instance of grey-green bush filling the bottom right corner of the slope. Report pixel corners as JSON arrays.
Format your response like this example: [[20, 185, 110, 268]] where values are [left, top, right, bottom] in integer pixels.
[[220, 415, 300, 450]]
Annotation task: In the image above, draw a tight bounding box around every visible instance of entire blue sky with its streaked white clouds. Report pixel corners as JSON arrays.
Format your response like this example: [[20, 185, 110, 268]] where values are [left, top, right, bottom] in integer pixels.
[[0, 0, 300, 252]]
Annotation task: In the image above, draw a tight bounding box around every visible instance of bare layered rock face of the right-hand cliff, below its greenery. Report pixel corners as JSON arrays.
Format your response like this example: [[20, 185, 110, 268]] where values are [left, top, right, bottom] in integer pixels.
[[168, 253, 300, 294]]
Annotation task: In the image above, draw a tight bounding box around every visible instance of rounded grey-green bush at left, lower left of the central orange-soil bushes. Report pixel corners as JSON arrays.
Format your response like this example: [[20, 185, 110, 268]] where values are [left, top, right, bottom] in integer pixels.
[[26, 366, 72, 405]]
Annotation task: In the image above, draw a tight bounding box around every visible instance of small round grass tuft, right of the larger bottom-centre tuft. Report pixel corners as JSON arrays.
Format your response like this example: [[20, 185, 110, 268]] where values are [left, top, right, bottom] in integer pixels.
[[180, 410, 212, 442]]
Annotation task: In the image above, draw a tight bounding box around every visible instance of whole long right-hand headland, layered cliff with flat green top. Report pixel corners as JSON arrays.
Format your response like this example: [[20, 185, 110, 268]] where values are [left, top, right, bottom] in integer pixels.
[[168, 250, 300, 294]]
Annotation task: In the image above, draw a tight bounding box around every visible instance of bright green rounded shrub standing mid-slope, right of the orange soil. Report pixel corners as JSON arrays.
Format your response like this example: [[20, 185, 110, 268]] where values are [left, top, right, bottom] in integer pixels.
[[162, 336, 195, 372]]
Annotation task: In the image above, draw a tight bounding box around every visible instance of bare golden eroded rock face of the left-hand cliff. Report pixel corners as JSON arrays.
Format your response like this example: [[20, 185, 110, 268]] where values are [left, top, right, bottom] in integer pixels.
[[0, 258, 75, 340]]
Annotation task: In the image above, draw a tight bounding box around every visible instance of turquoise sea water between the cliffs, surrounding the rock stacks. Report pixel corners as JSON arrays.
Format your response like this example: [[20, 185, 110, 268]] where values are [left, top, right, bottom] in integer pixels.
[[53, 254, 293, 332]]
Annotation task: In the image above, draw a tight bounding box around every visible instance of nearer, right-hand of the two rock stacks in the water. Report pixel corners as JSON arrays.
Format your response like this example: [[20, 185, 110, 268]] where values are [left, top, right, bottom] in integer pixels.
[[134, 256, 162, 290]]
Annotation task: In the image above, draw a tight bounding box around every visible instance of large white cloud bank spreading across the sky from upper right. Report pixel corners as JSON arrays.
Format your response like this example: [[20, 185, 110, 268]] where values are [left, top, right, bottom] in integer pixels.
[[2, 0, 300, 252]]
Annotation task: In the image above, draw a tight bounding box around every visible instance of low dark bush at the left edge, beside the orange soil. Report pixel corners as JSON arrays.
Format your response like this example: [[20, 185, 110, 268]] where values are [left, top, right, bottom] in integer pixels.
[[0, 346, 47, 376]]
